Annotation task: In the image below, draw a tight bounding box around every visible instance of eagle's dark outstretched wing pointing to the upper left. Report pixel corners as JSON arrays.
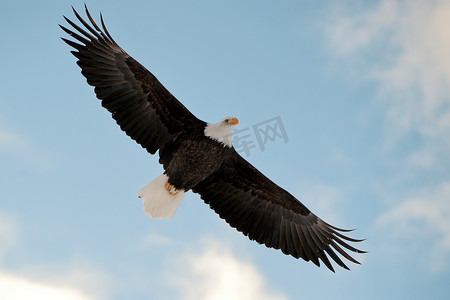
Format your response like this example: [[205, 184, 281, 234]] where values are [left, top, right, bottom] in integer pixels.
[[60, 8, 204, 154]]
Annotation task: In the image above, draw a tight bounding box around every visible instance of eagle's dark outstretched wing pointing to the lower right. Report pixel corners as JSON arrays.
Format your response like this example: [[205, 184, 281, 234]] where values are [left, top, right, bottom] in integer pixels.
[[193, 149, 364, 272]]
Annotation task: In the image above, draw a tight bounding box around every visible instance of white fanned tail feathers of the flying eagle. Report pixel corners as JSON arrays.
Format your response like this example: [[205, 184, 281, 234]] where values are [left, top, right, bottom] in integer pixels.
[[138, 174, 186, 220]]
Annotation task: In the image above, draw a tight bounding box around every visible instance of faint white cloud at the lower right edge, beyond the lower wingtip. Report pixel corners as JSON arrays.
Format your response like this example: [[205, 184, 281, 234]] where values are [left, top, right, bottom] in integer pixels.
[[377, 181, 450, 271]]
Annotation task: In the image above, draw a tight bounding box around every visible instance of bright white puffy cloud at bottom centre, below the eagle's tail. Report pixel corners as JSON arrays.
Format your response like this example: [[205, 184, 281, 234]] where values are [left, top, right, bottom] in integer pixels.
[[167, 241, 287, 300]]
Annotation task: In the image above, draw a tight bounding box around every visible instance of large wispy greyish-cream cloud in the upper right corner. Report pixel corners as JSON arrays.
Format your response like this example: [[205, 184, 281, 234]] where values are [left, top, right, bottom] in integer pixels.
[[327, 0, 450, 155]]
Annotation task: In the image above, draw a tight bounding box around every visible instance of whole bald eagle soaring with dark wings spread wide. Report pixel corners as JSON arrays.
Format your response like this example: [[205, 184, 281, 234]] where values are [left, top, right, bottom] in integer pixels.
[[60, 7, 365, 272]]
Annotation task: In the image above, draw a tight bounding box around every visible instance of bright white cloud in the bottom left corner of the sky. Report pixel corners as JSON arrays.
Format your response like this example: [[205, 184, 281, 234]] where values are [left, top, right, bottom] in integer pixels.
[[0, 212, 108, 300]]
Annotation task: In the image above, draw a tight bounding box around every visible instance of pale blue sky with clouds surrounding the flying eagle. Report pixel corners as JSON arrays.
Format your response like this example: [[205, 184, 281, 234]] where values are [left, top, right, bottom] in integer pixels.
[[0, 0, 450, 299]]
